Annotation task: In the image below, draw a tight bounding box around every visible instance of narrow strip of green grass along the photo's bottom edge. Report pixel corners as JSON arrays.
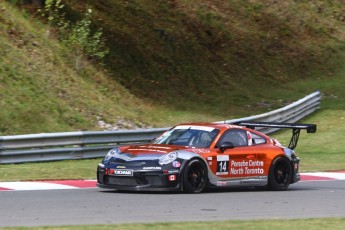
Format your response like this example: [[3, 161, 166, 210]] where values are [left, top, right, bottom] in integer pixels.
[[2, 218, 345, 230]]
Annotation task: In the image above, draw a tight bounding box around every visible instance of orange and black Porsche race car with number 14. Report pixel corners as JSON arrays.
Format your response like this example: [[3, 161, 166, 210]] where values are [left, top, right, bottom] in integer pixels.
[[97, 122, 316, 193]]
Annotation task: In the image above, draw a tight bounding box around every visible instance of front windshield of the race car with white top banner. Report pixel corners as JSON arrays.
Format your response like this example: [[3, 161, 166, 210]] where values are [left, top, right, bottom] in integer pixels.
[[153, 125, 219, 148]]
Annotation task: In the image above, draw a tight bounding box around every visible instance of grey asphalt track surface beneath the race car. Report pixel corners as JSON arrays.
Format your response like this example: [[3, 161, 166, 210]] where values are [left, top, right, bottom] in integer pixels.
[[0, 180, 345, 227]]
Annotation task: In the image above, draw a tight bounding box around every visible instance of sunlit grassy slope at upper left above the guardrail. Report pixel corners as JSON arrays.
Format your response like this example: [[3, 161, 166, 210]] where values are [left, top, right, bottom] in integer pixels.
[[0, 1, 152, 136]]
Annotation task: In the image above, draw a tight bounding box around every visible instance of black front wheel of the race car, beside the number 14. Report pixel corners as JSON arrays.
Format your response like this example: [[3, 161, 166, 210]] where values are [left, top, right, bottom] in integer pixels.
[[183, 159, 208, 193]]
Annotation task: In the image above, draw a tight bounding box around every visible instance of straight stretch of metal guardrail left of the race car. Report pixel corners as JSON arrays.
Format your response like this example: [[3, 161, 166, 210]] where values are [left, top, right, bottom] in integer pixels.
[[0, 128, 168, 164]]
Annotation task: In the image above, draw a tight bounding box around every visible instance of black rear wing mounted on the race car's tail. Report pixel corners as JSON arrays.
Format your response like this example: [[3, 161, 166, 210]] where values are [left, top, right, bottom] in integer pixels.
[[235, 121, 316, 149]]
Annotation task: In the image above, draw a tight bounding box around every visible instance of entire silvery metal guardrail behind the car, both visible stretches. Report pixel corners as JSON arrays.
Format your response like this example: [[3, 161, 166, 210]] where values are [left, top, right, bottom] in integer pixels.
[[0, 91, 321, 164]]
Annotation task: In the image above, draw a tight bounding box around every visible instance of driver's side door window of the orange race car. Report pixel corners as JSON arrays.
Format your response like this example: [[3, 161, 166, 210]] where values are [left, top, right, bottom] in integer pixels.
[[216, 129, 248, 148]]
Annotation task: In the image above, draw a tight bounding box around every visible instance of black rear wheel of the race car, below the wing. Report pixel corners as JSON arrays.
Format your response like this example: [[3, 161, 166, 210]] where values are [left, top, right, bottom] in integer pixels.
[[268, 157, 292, 191]]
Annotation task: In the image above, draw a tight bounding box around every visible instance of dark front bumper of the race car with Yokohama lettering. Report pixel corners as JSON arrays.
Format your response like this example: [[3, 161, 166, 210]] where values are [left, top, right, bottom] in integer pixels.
[[97, 166, 181, 191]]
